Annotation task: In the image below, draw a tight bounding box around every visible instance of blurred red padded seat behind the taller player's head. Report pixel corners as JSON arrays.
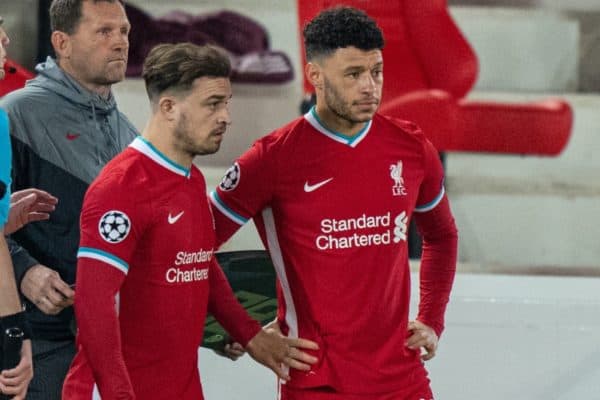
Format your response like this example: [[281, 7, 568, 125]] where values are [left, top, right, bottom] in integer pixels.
[[298, 0, 573, 156]]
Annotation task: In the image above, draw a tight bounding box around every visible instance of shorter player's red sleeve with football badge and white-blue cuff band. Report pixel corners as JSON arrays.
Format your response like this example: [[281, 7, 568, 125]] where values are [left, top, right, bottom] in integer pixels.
[[77, 175, 150, 274]]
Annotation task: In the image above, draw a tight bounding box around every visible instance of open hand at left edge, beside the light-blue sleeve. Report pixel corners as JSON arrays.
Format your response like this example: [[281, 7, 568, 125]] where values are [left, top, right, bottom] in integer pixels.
[[4, 189, 58, 235]]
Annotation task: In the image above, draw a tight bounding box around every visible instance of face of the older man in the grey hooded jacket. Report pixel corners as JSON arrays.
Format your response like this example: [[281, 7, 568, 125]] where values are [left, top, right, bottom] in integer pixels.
[[61, 1, 131, 87]]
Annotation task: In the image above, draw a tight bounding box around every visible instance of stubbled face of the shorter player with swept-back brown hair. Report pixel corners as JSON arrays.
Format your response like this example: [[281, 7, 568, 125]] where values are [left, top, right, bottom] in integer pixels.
[[174, 77, 232, 156]]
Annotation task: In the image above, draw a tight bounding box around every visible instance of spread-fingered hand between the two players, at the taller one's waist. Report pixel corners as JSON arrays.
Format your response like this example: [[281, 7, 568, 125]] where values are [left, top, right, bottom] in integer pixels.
[[246, 327, 319, 381]]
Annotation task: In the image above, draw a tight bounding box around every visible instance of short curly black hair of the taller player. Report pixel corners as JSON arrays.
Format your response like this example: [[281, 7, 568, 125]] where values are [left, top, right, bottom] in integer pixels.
[[303, 6, 384, 61]]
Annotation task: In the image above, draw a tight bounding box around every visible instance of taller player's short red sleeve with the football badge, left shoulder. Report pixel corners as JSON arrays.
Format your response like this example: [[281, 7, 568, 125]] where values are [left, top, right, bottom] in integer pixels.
[[210, 140, 276, 225]]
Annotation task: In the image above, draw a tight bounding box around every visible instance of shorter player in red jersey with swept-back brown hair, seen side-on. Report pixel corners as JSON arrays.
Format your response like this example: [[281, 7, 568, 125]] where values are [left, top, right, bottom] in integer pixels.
[[63, 43, 317, 400]]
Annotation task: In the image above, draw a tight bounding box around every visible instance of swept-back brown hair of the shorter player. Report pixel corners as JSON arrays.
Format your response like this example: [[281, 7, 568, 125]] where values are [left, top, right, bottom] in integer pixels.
[[142, 43, 231, 101]]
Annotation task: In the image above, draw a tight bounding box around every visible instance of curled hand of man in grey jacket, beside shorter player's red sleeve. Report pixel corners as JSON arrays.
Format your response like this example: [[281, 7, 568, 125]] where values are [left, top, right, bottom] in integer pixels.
[[21, 264, 75, 315]]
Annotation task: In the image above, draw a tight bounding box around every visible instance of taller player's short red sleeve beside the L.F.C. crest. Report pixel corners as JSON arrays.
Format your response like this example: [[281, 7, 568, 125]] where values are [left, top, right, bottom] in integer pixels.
[[415, 139, 445, 213]]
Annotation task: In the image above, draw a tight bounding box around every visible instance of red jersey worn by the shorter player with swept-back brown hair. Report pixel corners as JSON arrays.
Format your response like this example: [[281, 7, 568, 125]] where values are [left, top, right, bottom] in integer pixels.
[[63, 137, 260, 400]]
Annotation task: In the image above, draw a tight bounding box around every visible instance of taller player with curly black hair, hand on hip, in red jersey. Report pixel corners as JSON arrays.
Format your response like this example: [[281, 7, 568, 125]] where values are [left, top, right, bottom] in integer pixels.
[[210, 7, 457, 400]]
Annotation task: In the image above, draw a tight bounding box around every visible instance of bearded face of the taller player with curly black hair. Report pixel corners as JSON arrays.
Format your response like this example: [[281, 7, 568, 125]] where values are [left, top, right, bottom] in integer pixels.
[[319, 47, 383, 123]]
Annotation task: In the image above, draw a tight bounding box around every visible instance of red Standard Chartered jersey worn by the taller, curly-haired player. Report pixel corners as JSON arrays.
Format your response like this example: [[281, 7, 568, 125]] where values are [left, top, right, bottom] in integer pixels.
[[210, 108, 449, 394]]
